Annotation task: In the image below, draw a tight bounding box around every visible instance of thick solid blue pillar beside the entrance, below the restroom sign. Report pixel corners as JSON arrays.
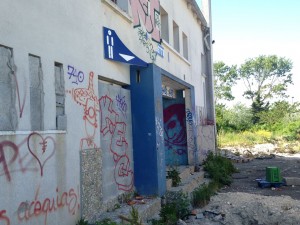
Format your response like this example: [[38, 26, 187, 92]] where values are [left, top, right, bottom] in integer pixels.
[[130, 64, 166, 196]]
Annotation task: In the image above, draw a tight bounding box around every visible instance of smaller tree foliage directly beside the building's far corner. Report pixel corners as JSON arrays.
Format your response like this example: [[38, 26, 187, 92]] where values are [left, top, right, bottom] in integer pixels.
[[214, 61, 238, 104]]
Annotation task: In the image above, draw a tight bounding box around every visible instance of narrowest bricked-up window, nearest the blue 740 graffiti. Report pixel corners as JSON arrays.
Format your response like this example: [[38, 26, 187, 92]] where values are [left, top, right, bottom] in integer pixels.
[[54, 63, 66, 130]]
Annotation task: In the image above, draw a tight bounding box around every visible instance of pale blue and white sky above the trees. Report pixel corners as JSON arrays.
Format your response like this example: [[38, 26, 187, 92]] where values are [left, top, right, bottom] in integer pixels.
[[198, 0, 300, 102]]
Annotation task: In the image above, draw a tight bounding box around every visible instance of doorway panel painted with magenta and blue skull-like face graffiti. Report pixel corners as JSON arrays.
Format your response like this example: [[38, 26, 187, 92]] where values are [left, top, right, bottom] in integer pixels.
[[163, 98, 188, 166]]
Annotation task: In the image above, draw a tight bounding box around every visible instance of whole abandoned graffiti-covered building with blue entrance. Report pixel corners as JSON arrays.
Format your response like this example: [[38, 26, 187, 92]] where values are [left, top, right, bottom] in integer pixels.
[[0, 0, 215, 225]]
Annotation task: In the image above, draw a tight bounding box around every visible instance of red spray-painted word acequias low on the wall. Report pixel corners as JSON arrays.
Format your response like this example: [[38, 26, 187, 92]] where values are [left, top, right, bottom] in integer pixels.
[[17, 188, 79, 225]]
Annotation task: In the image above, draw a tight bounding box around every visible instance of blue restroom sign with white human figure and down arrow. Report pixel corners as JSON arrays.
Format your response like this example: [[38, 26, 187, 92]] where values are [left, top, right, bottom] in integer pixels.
[[103, 27, 147, 67]]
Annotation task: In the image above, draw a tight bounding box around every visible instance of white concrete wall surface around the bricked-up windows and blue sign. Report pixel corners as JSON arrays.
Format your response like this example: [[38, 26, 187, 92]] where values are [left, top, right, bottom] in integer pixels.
[[0, 0, 212, 225]]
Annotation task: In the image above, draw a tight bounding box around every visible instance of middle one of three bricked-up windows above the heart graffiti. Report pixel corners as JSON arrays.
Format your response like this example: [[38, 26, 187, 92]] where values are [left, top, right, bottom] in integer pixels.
[[29, 55, 44, 130]]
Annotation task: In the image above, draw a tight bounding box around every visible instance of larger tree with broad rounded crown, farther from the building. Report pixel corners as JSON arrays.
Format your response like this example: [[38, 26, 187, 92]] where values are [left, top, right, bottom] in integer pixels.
[[239, 55, 293, 124]]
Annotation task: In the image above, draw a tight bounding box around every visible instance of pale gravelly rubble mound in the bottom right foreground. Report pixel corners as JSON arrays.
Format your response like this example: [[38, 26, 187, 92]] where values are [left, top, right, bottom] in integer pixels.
[[180, 192, 300, 225]]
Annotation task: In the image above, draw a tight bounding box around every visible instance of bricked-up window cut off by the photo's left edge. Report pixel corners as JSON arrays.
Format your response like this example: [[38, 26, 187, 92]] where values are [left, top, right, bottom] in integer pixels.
[[0, 46, 18, 131]]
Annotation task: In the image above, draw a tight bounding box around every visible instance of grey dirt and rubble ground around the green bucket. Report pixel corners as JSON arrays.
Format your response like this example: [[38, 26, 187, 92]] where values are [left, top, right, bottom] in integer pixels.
[[181, 154, 300, 225]]
